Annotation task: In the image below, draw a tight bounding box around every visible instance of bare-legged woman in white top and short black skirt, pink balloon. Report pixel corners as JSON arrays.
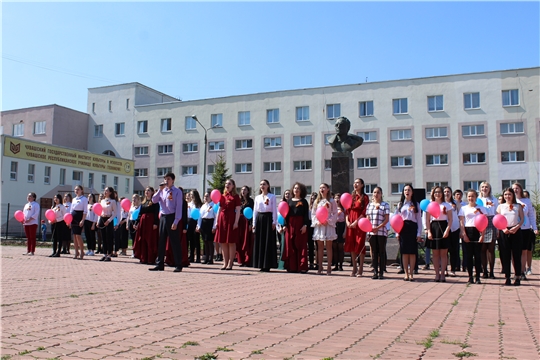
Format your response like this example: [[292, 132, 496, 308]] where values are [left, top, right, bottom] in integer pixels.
[[426, 186, 452, 282]]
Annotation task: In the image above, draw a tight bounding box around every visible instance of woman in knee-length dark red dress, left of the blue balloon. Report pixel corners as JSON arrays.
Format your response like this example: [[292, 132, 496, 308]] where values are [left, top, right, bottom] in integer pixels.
[[216, 179, 242, 270]]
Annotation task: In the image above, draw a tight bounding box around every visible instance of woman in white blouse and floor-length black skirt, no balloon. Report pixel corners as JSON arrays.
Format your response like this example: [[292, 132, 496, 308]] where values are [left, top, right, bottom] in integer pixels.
[[253, 179, 278, 272]]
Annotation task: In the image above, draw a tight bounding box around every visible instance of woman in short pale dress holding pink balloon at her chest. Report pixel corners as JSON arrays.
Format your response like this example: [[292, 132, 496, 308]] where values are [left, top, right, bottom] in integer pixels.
[[311, 183, 337, 275]]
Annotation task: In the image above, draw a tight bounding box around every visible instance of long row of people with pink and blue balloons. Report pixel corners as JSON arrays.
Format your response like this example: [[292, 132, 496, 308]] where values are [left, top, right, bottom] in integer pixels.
[[20, 173, 538, 285]]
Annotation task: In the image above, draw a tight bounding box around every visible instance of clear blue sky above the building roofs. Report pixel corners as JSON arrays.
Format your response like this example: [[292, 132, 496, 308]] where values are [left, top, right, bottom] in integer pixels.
[[0, 0, 540, 112]]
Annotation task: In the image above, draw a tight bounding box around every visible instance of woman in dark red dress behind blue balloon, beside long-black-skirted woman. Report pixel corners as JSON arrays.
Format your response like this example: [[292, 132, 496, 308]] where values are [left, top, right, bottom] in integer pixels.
[[236, 185, 254, 267]]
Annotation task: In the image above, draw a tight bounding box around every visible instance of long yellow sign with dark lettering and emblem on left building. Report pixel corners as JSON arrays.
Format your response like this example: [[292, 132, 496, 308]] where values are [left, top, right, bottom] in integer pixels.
[[4, 136, 133, 176]]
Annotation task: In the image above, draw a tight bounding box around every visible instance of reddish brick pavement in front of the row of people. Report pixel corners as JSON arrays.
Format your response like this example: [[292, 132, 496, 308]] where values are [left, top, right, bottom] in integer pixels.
[[0, 246, 540, 360]]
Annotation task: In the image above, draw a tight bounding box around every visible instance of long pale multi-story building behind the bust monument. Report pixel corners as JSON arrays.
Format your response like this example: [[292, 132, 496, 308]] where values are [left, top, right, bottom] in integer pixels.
[[82, 67, 540, 201]]
